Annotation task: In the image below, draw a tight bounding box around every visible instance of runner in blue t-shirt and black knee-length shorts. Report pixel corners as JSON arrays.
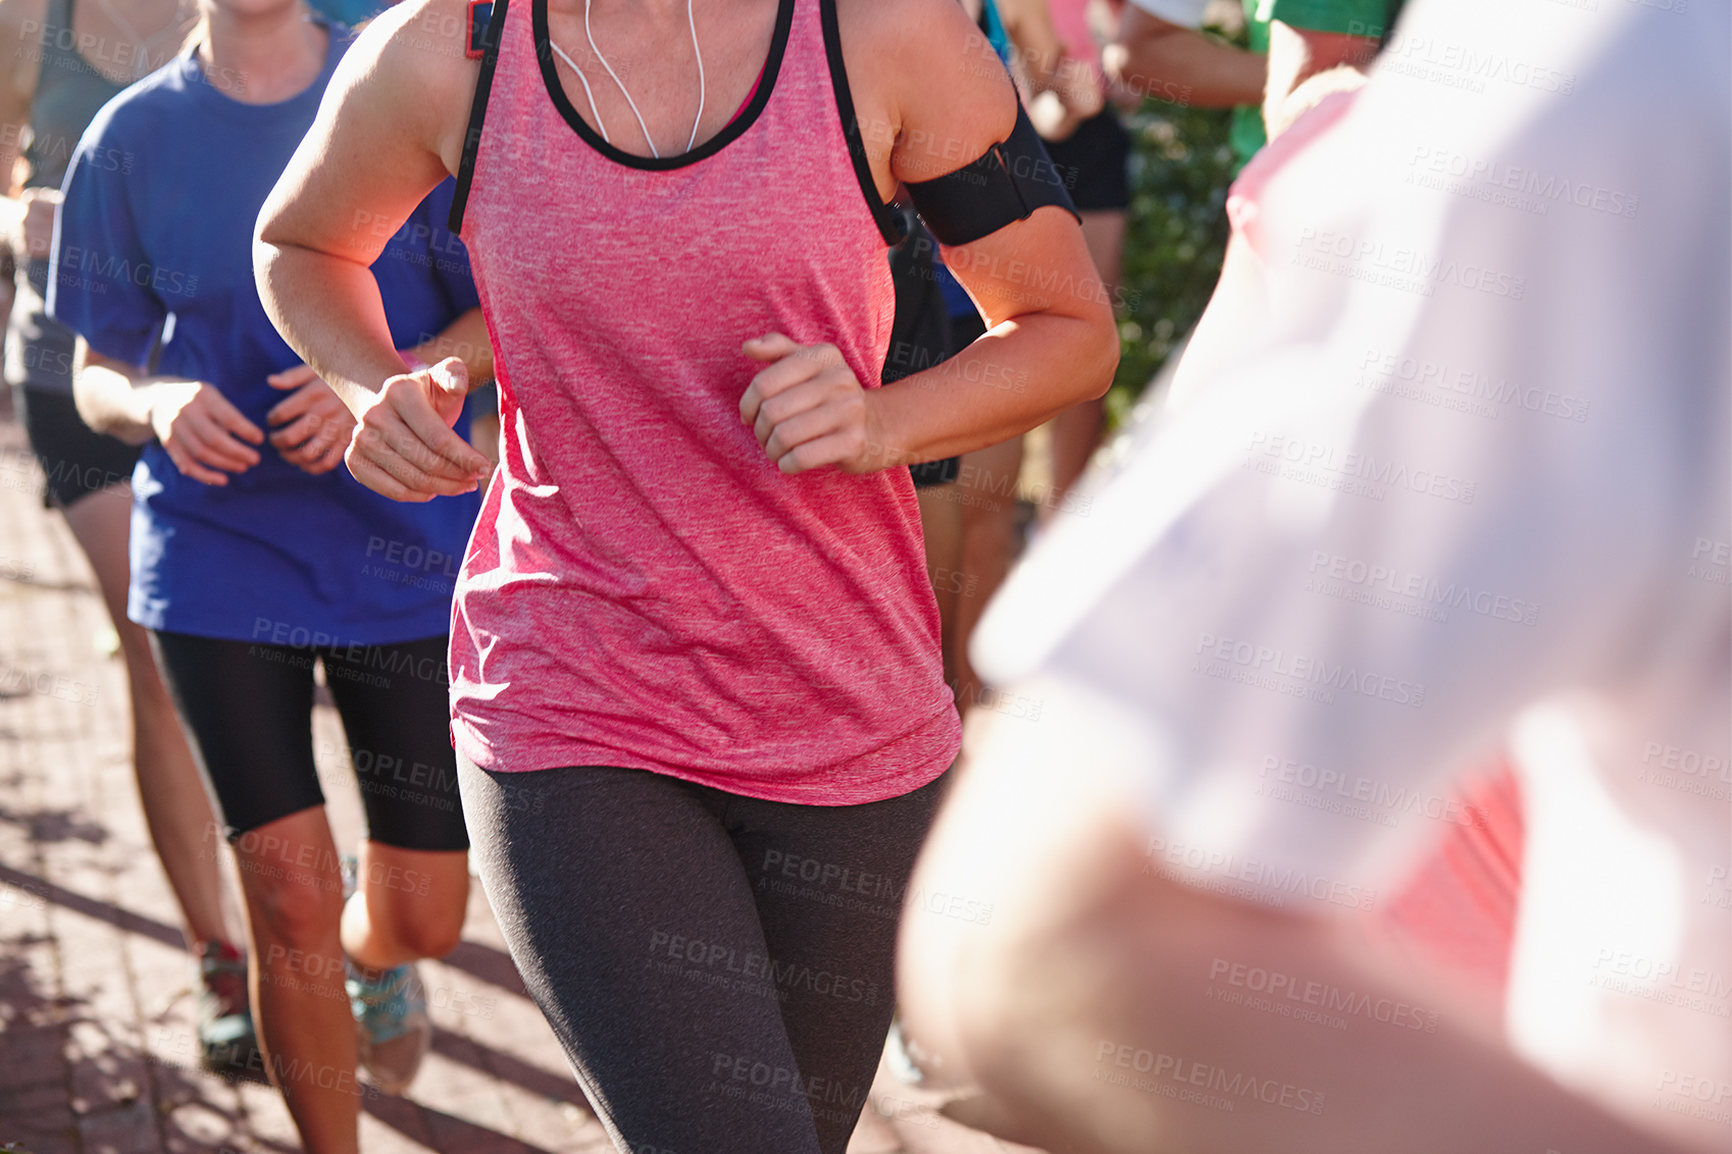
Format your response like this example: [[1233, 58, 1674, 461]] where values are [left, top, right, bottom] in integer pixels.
[[48, 0, 492, 1151]]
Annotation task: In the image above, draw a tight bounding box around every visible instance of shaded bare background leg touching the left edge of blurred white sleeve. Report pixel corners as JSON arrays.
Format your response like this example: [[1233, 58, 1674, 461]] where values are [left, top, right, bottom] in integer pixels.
[[953, 437, 1022, 712]]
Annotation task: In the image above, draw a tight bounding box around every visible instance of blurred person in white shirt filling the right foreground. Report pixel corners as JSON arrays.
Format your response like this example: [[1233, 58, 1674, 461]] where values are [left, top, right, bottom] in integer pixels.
[[902, 0, 1732, 1154]]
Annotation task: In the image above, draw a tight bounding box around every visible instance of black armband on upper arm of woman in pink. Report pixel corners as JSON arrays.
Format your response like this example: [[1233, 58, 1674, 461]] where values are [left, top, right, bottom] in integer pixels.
[[908, 104, 1081, 244]]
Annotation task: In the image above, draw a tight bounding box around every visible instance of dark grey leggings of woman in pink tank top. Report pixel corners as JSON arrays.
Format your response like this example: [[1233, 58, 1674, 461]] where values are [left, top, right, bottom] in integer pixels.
[[457, 757, 944, 1154]]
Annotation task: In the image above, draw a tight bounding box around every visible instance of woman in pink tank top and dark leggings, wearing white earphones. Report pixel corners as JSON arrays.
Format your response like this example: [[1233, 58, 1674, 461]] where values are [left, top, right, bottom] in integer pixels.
[[258, 0, 1117, 1154]]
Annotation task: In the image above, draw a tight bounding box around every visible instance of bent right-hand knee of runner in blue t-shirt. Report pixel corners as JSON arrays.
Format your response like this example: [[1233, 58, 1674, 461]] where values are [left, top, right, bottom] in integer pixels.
[[343, 842, 469, 970]]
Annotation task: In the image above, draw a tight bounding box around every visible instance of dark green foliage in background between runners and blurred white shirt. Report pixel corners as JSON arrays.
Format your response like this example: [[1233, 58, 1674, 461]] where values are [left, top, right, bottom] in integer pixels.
[[1107, 100, 1233, 428]]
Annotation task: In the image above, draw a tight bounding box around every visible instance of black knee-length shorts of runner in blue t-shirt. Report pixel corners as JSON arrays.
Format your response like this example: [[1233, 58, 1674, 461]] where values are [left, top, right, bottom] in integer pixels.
[[151, 632, 469, 851]]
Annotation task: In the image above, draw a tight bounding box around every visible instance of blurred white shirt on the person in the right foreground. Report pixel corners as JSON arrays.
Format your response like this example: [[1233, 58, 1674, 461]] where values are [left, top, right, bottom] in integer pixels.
[[973, 0, 1732, 1149]]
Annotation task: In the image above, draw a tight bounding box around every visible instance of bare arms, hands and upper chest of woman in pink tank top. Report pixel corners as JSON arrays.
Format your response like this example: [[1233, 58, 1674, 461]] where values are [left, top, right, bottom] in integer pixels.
[[256, 0, 1117, 501]]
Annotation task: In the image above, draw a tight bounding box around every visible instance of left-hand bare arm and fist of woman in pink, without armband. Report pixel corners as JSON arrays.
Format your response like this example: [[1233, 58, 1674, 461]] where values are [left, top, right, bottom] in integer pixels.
[[253, 0, 492, 501]]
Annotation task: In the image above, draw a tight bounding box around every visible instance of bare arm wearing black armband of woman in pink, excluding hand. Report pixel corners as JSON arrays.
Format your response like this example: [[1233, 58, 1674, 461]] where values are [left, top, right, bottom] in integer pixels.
[[793, 0, 1119, 468]]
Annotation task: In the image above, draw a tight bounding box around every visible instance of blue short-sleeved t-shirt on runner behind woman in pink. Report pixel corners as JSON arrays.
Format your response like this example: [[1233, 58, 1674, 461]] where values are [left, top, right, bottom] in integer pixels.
[[48, 24, 480, 646]]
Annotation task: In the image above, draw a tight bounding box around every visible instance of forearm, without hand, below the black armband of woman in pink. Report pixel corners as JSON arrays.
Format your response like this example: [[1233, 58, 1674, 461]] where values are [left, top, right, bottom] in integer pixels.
[[871, 312, 1119, 464]]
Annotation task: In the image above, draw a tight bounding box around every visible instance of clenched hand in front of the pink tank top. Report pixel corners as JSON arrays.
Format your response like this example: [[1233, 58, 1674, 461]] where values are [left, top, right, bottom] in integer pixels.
[[740, 333, 894, 473]]
